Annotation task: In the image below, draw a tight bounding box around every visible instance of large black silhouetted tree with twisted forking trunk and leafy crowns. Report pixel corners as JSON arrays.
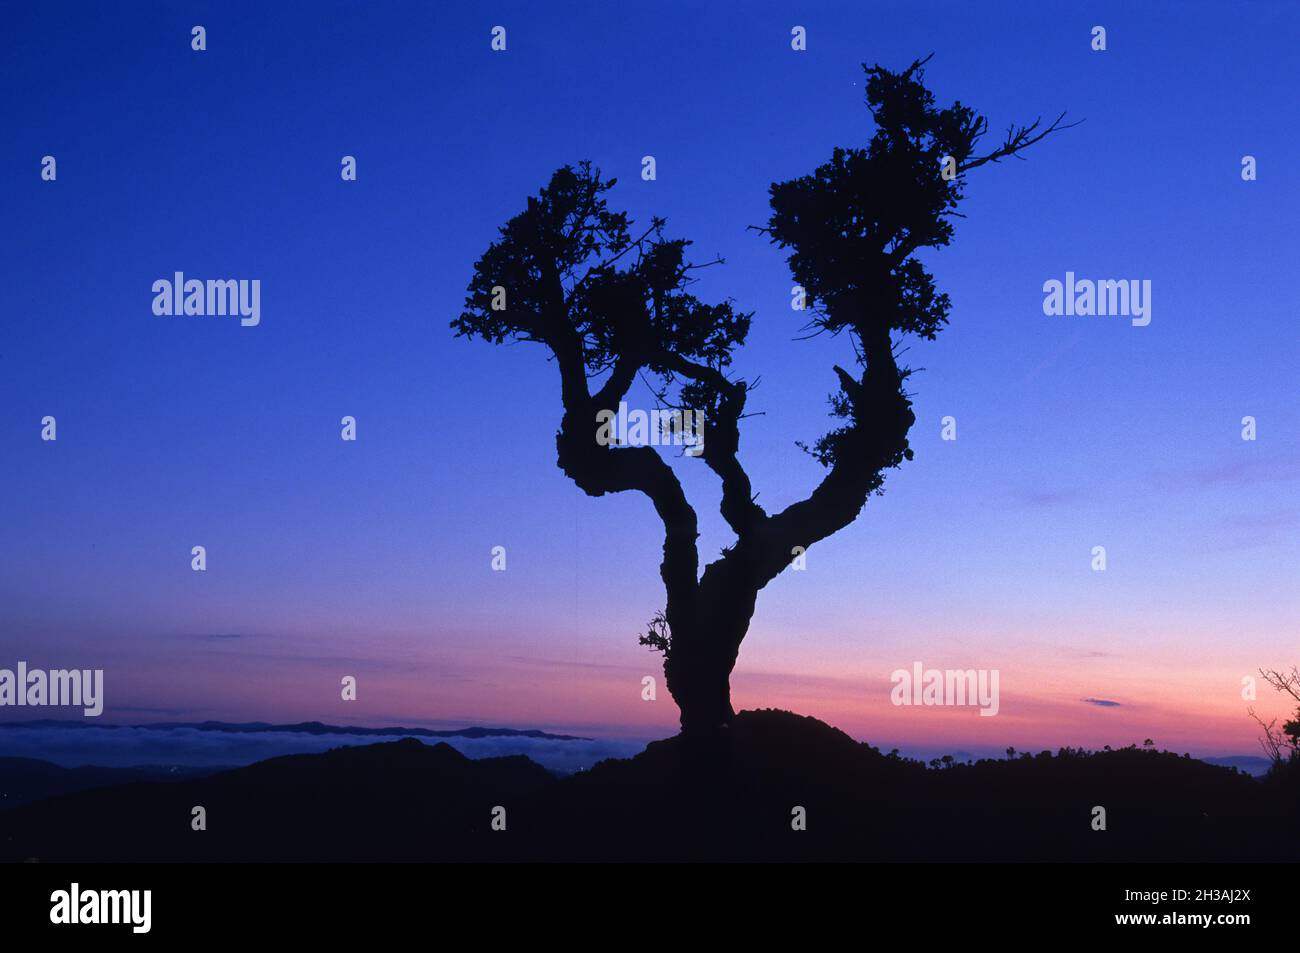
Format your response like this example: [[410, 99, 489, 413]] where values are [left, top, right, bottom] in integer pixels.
[[451, 60, 1063, 729]]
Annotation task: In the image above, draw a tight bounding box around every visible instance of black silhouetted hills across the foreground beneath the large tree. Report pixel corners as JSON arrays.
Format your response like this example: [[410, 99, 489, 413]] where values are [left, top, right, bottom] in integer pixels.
[[0, 710, 1300, 861]]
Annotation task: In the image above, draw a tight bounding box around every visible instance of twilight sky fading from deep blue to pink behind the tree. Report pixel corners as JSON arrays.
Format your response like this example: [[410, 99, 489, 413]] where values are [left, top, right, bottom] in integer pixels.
[[0, 3, 1300, 754]]
